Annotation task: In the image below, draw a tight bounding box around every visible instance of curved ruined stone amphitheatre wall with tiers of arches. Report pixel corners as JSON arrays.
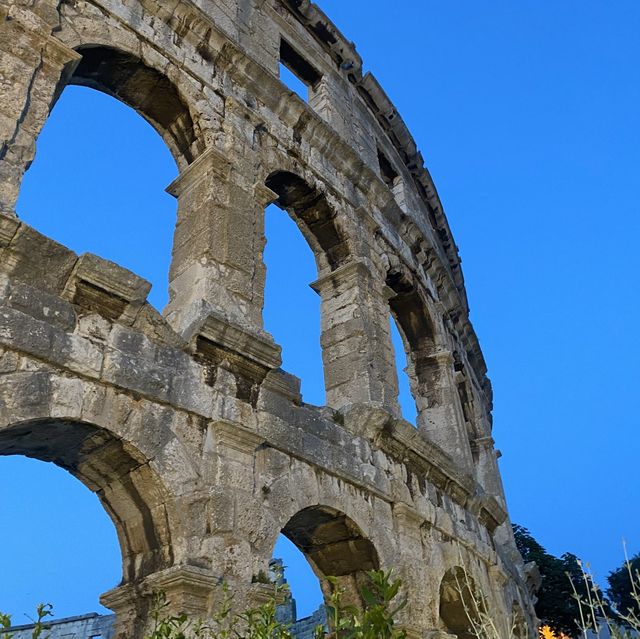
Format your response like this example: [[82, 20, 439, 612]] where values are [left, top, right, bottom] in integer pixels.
[[0, 0, 533, 638]]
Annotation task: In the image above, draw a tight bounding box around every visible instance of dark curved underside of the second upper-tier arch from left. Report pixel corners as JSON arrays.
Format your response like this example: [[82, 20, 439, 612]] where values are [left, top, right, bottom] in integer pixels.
[[265, 170, 350, 272]]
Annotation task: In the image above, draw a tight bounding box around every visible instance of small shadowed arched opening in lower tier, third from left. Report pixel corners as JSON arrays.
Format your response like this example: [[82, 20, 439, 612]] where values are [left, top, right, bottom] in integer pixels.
[[440, 567, 483, 639]]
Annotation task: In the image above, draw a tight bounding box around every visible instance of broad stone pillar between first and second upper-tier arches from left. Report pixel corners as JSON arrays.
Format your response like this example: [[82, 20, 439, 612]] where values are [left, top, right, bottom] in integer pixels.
[[165, 147, 278, 334]]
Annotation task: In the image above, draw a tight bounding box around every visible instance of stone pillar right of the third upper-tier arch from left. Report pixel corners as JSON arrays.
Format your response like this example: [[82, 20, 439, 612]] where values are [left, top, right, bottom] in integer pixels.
[[413, 350, 473, 472]]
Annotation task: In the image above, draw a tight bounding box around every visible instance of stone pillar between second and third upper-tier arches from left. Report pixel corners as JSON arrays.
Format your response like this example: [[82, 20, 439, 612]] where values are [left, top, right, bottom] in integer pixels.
[[312, 261, 399, 416]]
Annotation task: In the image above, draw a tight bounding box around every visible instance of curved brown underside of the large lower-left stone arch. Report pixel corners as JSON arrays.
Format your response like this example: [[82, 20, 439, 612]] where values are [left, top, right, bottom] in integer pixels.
[[0, 418, 173, 583]]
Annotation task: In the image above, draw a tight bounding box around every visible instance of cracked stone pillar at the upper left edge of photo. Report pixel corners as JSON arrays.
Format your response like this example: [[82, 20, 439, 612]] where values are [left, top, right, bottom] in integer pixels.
[[0, 11, 81, 216]]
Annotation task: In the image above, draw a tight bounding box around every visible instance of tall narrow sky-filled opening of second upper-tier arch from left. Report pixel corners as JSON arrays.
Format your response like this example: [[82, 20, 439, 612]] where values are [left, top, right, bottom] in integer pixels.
[[263, 205, 325, 406]]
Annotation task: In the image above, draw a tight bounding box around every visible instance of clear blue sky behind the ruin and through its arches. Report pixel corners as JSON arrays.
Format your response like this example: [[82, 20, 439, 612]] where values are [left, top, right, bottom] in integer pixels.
[[0, 0, 640, 621]]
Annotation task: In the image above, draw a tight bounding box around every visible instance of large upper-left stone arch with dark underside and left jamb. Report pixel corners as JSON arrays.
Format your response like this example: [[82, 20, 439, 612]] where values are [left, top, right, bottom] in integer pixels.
[[0, 27, 204, 216]]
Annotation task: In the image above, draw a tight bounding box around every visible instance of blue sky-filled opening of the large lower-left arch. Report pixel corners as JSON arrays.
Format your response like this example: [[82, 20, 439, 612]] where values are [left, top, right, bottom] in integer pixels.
[[0, 455, 122, 625]]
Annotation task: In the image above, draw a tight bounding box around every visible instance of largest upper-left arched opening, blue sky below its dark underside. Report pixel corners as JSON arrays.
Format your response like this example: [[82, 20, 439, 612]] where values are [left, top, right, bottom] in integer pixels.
[[16, 47, 190, 309]]
